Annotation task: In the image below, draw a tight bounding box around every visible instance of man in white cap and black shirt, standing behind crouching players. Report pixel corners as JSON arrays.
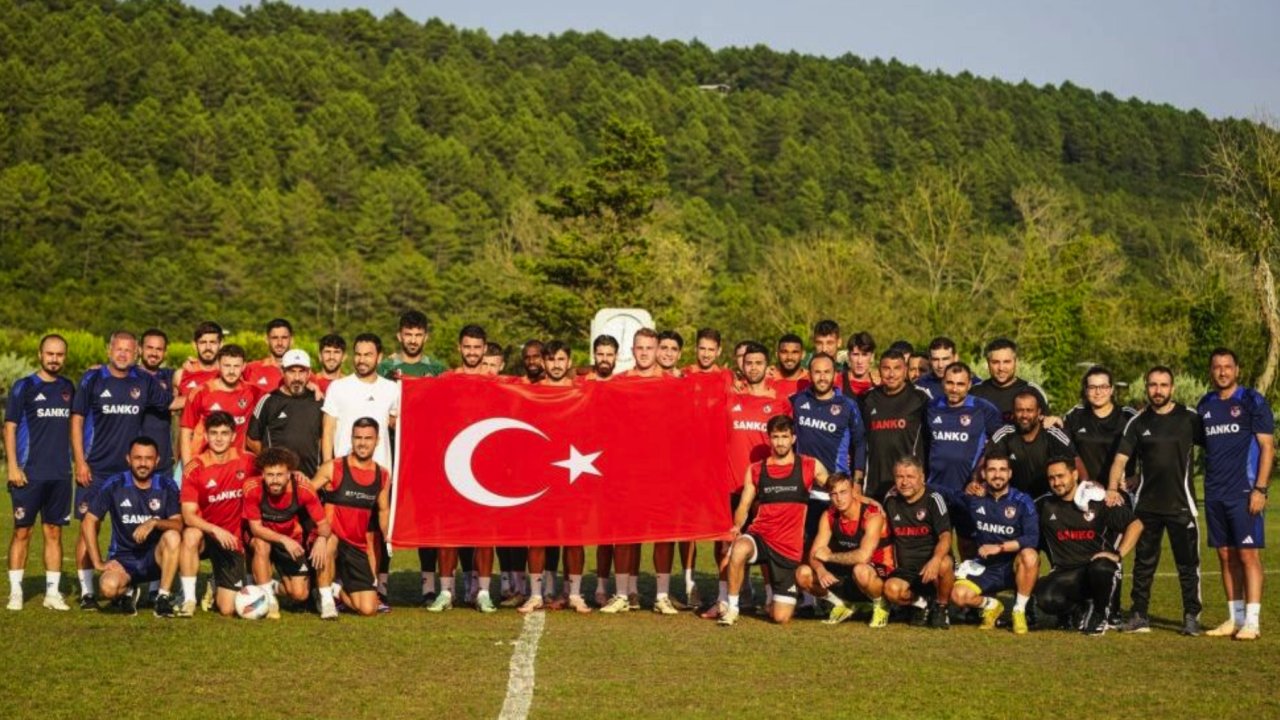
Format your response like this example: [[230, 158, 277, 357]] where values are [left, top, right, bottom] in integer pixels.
[[247, 348, 324, 478]]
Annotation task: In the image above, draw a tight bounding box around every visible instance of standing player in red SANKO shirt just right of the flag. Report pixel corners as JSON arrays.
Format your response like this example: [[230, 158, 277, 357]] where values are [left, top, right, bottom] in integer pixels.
[[701, 342, 778, 620]]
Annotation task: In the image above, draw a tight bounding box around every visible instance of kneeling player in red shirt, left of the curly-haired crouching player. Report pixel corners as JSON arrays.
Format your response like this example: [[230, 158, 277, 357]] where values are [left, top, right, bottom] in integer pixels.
[[175, 410, 253, 618]]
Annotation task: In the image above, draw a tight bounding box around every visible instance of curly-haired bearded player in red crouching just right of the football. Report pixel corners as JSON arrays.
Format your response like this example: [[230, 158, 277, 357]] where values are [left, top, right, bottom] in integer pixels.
[[243, 445, 332, 620]]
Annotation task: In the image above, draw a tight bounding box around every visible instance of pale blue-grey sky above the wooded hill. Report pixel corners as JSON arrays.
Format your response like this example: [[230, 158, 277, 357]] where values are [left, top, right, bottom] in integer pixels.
[[188, 0, 1280, 119]]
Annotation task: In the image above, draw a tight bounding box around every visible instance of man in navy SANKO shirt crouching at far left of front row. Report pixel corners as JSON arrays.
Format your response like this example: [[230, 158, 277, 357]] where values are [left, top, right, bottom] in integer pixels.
[[81, 437, 182, 618]]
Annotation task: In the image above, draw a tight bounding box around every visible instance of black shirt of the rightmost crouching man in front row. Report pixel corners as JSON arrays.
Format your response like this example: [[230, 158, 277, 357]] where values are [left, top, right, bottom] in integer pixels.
[[1036, 493, 1133, 570]]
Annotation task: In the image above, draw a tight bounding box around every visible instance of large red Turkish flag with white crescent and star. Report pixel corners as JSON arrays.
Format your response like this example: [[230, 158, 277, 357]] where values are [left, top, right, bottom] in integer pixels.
[[389, 374, 732, 547]]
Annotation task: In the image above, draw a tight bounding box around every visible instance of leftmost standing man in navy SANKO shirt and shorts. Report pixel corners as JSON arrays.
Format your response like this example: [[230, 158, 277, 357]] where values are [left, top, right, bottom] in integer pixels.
[[4, 334, 75, 610]]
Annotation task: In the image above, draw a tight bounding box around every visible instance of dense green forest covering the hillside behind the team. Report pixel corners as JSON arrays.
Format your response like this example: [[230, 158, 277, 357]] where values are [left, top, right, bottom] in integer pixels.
[[0, 0, 1266, 404]]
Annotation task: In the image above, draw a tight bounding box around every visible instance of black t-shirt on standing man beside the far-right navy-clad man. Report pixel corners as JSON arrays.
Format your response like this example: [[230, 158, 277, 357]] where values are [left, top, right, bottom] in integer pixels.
[[1116, 402, 1204, 515]]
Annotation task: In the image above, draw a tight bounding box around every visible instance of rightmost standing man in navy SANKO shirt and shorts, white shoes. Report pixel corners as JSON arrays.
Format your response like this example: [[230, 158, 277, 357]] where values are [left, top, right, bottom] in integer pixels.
[[1196, 347, 1275, 641]]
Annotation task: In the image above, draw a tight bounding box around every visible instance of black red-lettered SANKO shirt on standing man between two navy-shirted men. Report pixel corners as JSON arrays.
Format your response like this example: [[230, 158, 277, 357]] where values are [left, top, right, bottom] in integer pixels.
[[860, 386, 929, 500]]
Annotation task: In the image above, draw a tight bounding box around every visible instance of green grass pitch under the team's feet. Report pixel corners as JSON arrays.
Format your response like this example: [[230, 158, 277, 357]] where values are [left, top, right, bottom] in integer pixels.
[[0, 481, 1280, 720]]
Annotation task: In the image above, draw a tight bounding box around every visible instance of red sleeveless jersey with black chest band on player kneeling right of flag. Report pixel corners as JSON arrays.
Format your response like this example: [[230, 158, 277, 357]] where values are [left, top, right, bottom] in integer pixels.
[[748, 455, 815, 562]]
